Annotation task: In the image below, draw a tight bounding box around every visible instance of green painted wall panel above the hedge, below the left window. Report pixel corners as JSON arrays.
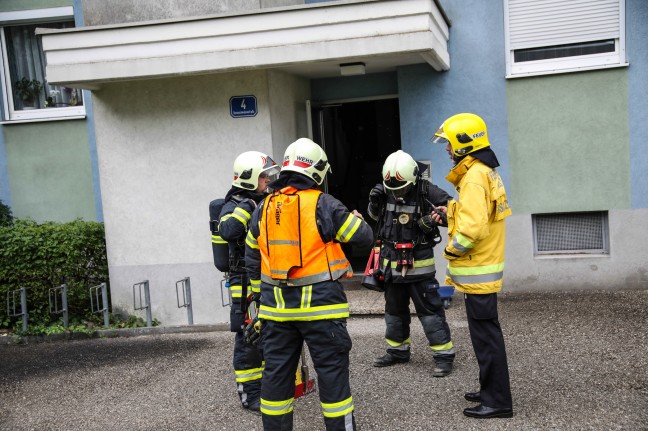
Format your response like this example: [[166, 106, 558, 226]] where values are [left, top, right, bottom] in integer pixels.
[[4, 120, 97, 222]]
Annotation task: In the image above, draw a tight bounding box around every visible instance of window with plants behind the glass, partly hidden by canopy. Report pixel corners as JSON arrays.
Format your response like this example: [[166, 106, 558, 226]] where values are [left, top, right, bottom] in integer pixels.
[[0, 7, 85, 121]]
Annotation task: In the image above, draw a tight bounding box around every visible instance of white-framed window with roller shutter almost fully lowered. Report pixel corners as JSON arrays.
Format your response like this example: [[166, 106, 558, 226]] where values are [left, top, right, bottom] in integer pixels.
[[504, 0, 627, 78]]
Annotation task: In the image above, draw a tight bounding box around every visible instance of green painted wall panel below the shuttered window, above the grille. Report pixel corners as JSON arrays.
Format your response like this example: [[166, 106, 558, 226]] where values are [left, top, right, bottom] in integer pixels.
[[507, 69, 631, 214]]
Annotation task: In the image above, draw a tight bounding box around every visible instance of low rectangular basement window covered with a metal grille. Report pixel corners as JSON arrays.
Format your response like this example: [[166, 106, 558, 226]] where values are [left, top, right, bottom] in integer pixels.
[[532, 212, 609, 255]]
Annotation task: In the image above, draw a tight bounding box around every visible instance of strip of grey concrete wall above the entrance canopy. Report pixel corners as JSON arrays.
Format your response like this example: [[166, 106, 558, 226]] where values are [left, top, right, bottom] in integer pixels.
[[82, 0, 304, 25]]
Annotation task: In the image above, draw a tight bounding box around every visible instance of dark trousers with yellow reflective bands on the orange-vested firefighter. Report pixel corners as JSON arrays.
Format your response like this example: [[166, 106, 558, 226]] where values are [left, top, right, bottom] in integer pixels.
[[261, 319, 355, 431]]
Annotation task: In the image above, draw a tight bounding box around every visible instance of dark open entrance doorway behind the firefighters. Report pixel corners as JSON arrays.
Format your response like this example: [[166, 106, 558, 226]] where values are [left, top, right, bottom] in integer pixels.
[[311, 98, 401, 274]]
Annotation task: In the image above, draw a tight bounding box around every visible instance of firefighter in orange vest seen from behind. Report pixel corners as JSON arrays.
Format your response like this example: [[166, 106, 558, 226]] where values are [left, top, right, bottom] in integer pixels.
[[245, 138, 373, 431]]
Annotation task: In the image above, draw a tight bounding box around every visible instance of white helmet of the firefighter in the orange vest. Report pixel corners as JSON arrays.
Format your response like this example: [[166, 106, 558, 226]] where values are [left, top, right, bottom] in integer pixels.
[[281, 138, 332, 185]]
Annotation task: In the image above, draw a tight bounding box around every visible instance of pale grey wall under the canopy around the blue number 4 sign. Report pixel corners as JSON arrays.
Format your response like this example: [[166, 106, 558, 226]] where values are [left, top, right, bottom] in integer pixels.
[[93, 70, 309, 325]]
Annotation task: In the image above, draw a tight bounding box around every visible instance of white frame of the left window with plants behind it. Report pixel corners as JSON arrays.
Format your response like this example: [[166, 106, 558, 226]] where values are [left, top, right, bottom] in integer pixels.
[[0, 6, 86, 124]]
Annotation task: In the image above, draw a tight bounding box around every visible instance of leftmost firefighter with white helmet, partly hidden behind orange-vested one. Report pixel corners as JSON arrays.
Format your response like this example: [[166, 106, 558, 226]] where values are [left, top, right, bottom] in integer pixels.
[[218, 151, 279, 412]]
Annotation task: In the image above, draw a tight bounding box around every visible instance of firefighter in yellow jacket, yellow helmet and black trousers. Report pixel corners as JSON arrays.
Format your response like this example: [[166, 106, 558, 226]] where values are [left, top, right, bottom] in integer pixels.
[[432, 113, 513, 418]]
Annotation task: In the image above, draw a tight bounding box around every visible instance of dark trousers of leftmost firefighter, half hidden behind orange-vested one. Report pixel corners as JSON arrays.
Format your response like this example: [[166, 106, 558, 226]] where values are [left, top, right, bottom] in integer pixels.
[[232, 303, 263, 407]]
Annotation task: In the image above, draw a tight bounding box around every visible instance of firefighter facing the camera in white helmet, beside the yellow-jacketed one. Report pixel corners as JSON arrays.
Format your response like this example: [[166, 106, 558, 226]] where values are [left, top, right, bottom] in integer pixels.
[[368, 150, 455, 377]]
